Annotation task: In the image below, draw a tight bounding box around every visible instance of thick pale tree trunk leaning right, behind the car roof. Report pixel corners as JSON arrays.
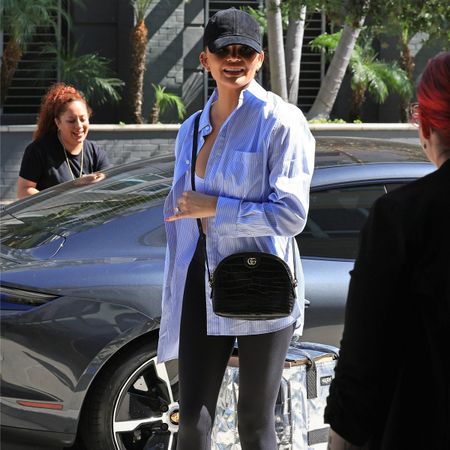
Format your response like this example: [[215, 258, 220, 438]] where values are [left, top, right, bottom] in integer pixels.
[[307, 17, 365, 120]]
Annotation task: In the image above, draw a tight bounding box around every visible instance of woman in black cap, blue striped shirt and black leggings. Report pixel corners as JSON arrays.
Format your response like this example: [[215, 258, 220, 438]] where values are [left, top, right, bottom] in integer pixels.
[[158, 9, 315, 450]]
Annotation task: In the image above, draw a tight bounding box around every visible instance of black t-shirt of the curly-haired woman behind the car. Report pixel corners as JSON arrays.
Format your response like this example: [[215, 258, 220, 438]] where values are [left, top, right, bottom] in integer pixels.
[[19, 133, 111, 191]]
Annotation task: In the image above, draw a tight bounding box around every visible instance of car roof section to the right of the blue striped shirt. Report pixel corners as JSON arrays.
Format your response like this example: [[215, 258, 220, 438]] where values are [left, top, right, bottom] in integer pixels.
[[315, 136, 428, 168]]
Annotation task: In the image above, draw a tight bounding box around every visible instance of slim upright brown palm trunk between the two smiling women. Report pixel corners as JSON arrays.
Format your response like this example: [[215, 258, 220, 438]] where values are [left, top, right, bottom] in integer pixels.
[[128, 20, 148, 123]]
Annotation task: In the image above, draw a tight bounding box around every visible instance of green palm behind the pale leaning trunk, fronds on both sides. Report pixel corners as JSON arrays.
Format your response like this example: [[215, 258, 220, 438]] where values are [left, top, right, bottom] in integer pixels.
[[310, 31, 412, 120]]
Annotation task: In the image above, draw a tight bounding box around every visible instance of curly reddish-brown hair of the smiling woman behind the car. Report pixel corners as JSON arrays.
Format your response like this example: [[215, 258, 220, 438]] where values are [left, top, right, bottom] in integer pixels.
[[33, 83, 92, 140]]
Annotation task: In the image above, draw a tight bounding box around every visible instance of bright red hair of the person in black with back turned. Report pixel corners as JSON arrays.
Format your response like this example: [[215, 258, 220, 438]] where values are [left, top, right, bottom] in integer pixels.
[[417, 52, 450, 144]]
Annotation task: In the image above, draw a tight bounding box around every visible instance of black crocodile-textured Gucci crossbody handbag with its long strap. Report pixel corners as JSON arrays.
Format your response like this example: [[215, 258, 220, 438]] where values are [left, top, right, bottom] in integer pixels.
[[191, 114, 297, 320]]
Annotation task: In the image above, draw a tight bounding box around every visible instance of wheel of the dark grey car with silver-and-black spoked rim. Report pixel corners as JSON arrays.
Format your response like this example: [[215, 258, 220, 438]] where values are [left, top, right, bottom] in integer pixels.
[[81, 343, 179, 450]]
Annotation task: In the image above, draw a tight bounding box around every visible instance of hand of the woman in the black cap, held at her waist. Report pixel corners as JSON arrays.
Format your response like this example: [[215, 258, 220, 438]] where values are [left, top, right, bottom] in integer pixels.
[[165, 191, 217, 222]]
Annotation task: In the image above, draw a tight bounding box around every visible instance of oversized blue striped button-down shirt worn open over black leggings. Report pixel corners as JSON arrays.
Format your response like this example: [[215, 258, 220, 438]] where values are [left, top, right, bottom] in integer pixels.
[[158, 81, 315, 362]]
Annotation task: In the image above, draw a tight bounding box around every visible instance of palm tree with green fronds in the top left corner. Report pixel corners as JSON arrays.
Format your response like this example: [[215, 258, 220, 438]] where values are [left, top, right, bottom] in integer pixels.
[[0, 0, 68, 104]]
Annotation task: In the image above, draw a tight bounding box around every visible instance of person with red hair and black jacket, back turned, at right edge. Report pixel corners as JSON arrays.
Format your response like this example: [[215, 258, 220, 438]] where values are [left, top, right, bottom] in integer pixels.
[[325, 52, 450, 450]]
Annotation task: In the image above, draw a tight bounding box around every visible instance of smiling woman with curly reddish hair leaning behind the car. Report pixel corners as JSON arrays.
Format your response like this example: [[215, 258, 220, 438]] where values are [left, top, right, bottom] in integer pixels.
[[17, 83, 110, 199]]
